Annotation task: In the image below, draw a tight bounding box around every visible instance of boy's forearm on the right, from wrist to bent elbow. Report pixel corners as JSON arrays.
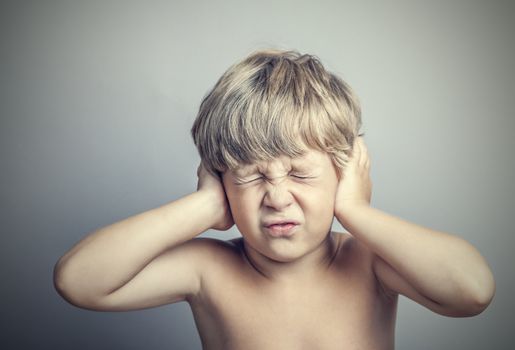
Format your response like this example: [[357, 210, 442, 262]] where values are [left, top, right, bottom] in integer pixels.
[[337, 205, 493, 305]]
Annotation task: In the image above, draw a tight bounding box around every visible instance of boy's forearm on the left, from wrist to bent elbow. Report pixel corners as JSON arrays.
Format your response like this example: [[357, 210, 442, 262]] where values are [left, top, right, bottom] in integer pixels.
[[55, 192, 220, 298]]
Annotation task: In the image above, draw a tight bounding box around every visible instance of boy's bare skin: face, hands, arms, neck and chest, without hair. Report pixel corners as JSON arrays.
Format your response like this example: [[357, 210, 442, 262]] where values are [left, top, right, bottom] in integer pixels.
[[55, 138, 495, 350]]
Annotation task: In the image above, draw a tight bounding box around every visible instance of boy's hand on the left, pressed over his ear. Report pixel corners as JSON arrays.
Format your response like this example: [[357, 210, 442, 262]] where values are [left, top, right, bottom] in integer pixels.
[[197, 163, 234, 231]]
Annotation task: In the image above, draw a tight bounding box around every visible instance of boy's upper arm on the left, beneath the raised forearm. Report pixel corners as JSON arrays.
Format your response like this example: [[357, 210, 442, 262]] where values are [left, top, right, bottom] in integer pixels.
[[79, 238, 220, 311]]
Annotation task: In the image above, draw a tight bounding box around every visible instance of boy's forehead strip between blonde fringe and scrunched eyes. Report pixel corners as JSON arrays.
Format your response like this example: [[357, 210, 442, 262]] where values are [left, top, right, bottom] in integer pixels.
[[232, 149, 332, 176]]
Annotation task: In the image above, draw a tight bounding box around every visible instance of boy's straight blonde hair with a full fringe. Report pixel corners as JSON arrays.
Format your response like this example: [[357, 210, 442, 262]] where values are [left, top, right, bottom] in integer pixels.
[[191, 49, 361, 173]]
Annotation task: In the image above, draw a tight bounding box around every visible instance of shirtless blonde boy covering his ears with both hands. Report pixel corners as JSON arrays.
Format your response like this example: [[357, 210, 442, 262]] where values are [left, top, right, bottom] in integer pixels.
[[55, 50, 494, 350]]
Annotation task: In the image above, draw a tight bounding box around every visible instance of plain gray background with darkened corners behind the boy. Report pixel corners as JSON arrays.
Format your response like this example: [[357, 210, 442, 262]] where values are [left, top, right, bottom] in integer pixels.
[[0, 0, 515, 349]]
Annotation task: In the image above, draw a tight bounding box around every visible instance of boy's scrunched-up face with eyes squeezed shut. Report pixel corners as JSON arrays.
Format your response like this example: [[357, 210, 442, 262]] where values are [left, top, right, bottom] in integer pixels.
[[223, 149, 338, 261]]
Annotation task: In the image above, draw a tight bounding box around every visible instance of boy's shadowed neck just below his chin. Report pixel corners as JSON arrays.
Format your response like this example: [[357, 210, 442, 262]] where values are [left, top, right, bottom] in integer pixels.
[[242, 232, 338, 283]]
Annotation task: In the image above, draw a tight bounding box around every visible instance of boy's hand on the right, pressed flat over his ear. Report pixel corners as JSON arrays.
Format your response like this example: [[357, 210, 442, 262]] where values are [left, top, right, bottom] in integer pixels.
[[334, 136, 372, 220]]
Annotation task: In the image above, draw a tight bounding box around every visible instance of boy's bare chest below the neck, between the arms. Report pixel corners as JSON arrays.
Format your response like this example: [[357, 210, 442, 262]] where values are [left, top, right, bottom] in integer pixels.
[[192, 279, 396, 350]]
